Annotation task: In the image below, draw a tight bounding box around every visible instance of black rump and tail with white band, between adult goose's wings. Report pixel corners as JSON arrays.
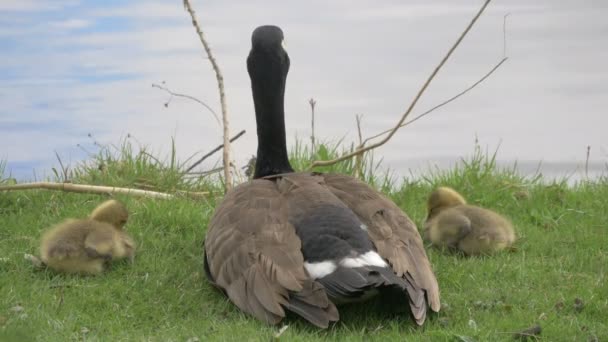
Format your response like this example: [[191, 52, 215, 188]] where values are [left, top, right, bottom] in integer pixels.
[[292, 205, 407, 304]]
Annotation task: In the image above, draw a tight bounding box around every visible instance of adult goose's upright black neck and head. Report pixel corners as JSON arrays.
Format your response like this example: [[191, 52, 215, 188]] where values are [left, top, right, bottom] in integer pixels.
[[247, 26, 293, 178]]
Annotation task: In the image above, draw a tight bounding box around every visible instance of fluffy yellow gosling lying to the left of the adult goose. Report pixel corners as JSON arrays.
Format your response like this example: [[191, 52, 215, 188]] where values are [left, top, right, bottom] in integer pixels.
[[39, 200, 135, 274]]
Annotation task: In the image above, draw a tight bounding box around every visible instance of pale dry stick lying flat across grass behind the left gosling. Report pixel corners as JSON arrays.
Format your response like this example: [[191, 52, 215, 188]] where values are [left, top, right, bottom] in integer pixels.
[[0, 182, 173, 199]]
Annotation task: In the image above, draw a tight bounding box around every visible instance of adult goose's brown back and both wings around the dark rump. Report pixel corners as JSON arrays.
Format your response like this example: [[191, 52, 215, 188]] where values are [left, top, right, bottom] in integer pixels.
[[205, 173, 440, 328]]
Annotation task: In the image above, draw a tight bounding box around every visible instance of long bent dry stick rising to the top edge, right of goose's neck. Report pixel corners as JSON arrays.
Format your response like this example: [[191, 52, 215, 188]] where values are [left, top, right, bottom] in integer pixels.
[[308, 0, 492, 169]]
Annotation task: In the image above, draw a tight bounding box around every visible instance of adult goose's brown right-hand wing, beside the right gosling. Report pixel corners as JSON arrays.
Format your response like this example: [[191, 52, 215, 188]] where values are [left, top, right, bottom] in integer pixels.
[[324, 174, 440, 318]]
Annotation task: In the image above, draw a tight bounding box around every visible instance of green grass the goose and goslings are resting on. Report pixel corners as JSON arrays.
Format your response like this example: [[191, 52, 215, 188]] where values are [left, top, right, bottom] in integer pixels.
[[0, 140, 608, 341]]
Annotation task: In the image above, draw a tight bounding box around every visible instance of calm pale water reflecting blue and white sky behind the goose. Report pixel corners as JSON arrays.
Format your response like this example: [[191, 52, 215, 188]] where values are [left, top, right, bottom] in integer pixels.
[[0, 0, 608, 178]]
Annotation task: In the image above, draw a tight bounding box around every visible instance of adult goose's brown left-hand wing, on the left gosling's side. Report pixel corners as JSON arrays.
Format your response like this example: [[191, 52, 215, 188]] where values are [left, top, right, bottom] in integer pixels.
[[205, 179, 338, 327]]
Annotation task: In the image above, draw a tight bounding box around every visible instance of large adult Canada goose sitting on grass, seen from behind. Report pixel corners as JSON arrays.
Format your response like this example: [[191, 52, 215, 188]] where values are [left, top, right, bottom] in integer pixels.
[[204, 26, 440, 328]]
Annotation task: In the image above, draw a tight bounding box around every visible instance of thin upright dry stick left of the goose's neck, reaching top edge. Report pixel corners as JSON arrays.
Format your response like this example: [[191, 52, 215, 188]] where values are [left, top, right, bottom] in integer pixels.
[[184, 0, 232, 192]]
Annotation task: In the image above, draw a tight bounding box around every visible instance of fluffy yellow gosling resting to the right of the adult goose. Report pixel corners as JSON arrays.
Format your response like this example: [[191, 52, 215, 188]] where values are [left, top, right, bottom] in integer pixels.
[[423, 187, 515, 255]]
